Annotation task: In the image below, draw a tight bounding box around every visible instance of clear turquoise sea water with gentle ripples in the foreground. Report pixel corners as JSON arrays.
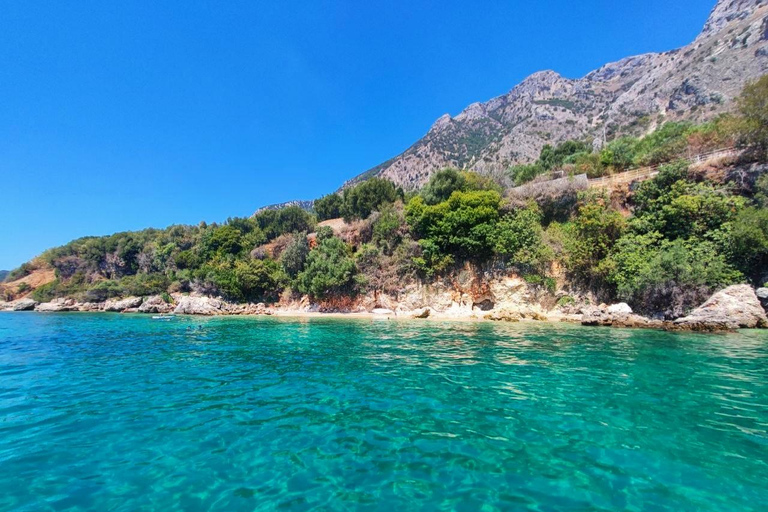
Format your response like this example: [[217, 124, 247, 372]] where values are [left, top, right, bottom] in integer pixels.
[[0, 313, 768, 511]]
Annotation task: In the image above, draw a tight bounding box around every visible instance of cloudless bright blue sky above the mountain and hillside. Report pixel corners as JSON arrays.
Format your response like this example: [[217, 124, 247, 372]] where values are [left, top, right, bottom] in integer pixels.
[[0, 0, 715, 269]]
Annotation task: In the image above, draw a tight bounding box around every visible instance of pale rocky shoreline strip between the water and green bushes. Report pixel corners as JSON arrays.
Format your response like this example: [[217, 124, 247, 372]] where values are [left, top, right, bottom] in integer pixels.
[[0, 285, 768, 332]]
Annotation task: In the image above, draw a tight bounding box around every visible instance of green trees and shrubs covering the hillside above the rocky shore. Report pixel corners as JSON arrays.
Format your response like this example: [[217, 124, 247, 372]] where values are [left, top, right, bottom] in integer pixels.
[[10, 79, 768, 317]]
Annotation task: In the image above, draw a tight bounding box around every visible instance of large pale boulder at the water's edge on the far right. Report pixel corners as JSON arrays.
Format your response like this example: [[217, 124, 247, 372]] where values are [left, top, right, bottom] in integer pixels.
[[670, 284, 768, 332]]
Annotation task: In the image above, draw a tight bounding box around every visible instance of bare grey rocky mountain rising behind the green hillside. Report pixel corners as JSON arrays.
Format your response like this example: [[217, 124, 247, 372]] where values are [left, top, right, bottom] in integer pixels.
[[345, 0, 768, 189]]
